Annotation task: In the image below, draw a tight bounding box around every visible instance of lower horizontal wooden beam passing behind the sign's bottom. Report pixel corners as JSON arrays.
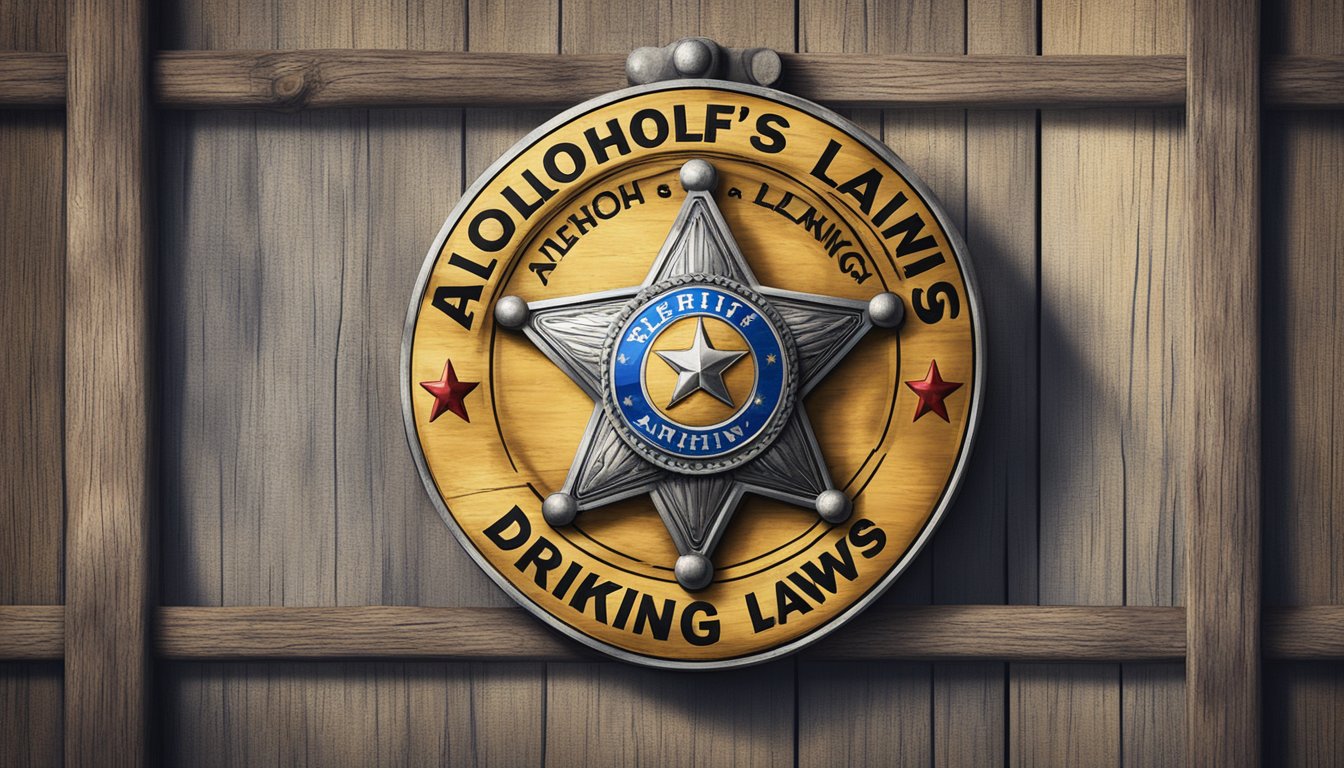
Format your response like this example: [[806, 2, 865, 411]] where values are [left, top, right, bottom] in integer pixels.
[[0, 605, 1344, 662]]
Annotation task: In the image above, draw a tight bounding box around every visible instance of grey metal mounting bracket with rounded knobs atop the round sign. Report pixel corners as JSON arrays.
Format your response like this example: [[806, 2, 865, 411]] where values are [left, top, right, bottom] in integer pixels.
[[625, 38, 784, 87]]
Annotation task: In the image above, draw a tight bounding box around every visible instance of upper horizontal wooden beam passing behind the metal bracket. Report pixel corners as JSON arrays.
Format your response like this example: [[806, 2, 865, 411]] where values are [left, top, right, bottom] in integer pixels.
[[0, 50, 1344, 110]]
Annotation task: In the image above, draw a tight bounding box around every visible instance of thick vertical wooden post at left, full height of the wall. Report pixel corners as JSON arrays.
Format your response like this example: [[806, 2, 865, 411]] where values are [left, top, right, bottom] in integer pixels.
[[65, 0, 153, 765]]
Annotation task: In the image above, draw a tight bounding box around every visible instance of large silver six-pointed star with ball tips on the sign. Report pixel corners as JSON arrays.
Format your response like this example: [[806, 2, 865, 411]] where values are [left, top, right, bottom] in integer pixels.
[[495, 160, 903, 590]]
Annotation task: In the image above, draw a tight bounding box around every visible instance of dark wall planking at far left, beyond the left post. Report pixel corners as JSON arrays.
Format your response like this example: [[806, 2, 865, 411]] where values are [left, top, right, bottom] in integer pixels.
[[0, 7, 66, 768]]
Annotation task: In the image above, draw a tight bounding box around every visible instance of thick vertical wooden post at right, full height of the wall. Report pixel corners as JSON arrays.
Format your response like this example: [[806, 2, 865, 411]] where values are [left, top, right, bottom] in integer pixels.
[[1185, 0, 1261, 765]]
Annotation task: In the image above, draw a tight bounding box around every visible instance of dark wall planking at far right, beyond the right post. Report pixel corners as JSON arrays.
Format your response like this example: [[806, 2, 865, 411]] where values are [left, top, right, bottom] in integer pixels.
[[1261, 0, 1344, 765]]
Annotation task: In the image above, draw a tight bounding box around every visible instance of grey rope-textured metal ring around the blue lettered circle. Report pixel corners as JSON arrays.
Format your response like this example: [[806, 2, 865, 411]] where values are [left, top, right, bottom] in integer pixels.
[[602, 274, 798, 475]]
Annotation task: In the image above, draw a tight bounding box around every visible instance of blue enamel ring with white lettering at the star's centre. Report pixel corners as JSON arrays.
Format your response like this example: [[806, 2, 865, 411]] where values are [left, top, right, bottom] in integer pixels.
[[609, 282, 790, 460]]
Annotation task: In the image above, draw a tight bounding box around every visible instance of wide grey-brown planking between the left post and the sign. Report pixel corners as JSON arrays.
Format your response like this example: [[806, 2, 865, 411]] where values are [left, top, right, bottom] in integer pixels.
[[159, 0, 544, 764]]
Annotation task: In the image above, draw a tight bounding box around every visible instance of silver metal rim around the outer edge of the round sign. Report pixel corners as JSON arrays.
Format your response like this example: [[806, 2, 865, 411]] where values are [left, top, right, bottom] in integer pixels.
[[399, 78, 986, 671]]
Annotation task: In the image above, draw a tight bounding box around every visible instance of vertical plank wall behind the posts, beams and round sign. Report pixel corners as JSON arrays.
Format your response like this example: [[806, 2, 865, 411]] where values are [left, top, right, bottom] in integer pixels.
[[0, 0, 1344, 767]]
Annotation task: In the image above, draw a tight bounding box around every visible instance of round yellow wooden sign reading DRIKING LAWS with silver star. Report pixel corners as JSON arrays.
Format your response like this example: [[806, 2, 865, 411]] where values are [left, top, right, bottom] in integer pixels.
[[402, 81, 984, 668]]
